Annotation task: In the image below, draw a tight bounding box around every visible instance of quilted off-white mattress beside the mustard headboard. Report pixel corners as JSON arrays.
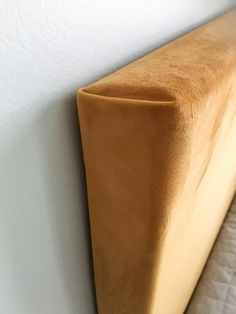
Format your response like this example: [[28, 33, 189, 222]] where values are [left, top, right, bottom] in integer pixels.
[[185, 196, 236, 314]]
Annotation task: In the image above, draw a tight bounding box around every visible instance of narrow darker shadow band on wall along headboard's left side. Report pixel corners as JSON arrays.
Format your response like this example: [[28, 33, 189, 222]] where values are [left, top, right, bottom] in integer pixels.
[[38, 95, 97, 314]]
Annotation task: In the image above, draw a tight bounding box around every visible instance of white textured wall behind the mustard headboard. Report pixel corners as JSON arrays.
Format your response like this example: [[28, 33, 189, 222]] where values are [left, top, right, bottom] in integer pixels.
[[0, 0, 233, 314]]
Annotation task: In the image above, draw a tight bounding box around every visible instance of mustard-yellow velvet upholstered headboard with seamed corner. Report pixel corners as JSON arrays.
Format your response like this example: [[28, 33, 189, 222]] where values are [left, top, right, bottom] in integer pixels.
[[78, 11, 236, 314]]
